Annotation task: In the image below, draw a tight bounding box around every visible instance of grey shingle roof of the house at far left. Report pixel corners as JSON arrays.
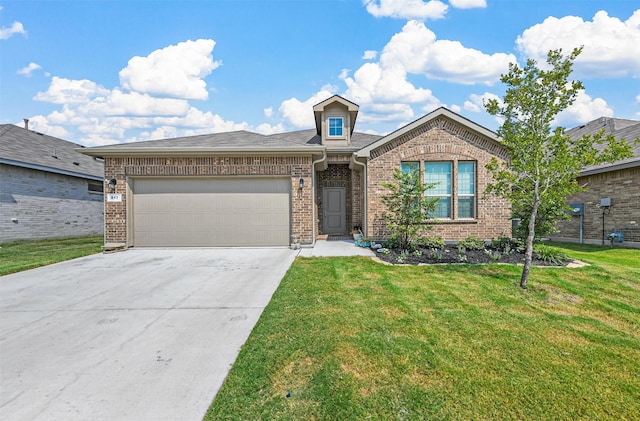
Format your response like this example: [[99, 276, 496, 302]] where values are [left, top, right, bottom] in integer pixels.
[[0, 124, 104, 178]]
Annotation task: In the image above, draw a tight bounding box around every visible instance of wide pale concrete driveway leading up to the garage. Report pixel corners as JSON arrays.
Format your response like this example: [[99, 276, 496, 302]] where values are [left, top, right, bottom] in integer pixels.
[[0, 248, 296, 420]]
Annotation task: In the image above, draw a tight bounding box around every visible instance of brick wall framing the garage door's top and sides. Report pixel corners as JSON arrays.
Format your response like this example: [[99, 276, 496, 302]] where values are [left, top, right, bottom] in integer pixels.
[[105, 156, 313, 244]]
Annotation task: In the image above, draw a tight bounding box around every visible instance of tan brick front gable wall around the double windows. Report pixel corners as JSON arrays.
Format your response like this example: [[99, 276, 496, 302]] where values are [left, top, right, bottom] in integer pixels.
[[367, 121, 511, 240]]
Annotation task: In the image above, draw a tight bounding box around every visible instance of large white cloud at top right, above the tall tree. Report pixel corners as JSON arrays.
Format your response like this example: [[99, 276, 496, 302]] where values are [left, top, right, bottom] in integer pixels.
[[516, 9, 640, 78]]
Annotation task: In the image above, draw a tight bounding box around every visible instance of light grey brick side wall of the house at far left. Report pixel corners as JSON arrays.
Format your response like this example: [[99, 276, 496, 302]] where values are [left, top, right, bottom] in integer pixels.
[[0, 164, 104, 243]]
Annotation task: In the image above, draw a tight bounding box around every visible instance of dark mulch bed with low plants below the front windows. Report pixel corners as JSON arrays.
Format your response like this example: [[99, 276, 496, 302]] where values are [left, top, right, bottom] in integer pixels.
[[376, 245, 568, 266]]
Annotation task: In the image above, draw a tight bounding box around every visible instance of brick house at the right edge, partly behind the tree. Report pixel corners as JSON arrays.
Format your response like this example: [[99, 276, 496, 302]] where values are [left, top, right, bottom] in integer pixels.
[[551, 117, 640, 247]]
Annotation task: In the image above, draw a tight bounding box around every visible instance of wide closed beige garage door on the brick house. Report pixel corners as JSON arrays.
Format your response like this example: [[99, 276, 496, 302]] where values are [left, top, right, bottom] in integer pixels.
[[131, 177, 291, 247]]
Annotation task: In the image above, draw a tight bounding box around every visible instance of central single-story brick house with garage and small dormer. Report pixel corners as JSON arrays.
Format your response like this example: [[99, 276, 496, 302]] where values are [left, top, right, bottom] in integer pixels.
[[80, 96, 511, 246]]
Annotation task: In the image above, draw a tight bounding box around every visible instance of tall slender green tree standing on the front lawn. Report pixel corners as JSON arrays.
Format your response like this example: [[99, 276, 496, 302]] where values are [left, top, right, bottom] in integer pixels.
[[485, 47, 632, 288]]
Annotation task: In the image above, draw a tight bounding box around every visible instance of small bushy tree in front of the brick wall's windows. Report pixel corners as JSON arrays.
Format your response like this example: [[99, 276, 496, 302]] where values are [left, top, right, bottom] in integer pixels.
[[381, 168, 438, 250]]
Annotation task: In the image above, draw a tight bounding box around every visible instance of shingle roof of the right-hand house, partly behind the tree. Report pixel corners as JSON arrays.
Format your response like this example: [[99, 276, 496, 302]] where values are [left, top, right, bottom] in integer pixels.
[[566, 117, 640, 174]]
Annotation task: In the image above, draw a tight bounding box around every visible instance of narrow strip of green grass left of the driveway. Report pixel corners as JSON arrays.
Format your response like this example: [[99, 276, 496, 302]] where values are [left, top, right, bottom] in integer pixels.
[[0, 236, 103, 276]]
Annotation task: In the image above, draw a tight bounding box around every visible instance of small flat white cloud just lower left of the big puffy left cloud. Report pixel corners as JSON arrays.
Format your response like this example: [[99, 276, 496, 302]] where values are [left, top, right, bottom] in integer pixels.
[[33, 76, 109, 104]]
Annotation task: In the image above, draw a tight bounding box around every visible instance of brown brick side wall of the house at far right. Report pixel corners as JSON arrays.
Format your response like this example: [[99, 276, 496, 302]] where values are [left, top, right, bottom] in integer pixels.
[[551, 167, 640, 247]]
